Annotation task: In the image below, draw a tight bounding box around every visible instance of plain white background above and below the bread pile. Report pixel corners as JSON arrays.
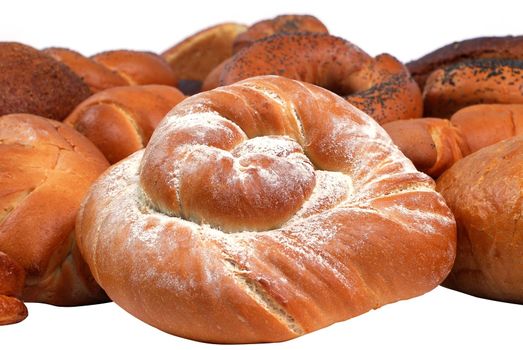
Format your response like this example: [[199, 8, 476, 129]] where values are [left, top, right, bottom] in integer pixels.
[[0, 0, 523, 350]]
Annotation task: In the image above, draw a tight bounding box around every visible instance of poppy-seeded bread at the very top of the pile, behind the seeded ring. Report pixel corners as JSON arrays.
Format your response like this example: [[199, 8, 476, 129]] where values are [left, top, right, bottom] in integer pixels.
[[233, 15, 329, 53]]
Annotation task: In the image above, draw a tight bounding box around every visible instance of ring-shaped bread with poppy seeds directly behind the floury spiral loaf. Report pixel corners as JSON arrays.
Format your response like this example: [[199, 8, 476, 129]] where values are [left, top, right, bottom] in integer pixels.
[[204, 33, 422, 124]]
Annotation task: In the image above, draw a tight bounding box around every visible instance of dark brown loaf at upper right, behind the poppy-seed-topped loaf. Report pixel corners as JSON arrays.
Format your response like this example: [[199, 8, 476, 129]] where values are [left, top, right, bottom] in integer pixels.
[[407, 36, 523, 90]]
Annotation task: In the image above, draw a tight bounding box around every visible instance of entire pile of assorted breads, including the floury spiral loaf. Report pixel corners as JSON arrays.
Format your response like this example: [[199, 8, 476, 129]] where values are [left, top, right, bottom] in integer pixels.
[[0, 15, 523, 343]]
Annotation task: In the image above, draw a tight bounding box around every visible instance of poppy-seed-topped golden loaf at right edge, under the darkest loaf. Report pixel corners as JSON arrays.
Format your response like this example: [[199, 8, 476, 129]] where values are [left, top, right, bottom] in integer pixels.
[[423, 58, 523, 118]]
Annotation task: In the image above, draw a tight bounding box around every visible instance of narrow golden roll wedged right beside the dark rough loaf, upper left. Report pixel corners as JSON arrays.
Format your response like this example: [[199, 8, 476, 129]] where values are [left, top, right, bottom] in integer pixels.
[[42, 47, 129, 93]]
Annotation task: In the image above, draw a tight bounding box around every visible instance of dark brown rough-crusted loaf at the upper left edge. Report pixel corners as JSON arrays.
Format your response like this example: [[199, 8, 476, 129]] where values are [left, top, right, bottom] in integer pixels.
[[0, 42, 91, 120]]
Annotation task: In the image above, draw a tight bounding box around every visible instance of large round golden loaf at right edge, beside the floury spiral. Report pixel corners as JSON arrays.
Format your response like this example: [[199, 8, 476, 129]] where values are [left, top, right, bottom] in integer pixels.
[[437, 136, 523, 303]]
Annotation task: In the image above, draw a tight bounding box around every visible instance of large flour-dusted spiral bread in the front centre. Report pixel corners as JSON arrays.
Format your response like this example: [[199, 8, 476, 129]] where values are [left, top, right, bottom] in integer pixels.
[[77, 76, 455, 343]]
